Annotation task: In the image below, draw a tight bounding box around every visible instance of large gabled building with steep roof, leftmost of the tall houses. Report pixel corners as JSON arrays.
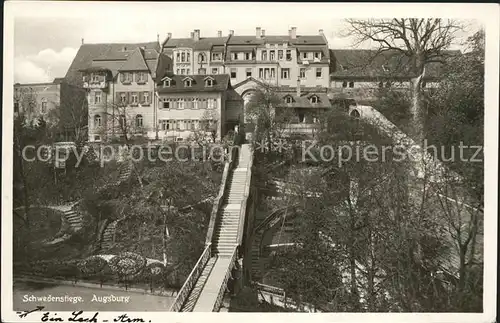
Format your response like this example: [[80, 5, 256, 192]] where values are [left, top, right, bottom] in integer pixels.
[[66, 42, 159, 141]]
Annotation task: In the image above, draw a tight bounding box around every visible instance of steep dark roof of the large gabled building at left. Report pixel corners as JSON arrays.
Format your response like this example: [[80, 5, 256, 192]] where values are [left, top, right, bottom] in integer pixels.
[[65, 42, 159, 85]]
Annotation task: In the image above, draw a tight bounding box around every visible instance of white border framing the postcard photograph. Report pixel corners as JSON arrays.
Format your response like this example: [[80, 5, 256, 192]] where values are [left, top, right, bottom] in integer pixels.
[[1, 1, 500, 323]]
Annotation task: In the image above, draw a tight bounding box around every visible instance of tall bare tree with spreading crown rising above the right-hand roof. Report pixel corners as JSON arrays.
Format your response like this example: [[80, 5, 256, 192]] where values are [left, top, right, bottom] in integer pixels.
[[346, 18, 462, 143]]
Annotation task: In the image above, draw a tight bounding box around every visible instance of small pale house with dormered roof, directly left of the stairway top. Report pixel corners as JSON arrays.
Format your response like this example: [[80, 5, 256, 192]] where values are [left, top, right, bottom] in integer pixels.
[[157, 74, 243, 141]]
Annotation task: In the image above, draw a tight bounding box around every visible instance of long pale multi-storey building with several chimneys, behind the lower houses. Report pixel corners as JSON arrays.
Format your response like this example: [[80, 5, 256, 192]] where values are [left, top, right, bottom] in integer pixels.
[[162, 27, 330, 87]]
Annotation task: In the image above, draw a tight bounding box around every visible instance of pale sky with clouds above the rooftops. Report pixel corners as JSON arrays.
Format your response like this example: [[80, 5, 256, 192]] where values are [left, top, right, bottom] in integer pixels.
[[7, 2, 479, 83]]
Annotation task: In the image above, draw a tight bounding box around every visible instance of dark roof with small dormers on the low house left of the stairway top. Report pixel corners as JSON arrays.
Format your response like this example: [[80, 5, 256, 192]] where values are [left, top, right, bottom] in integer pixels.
[[158, 74, 231, 94]]
